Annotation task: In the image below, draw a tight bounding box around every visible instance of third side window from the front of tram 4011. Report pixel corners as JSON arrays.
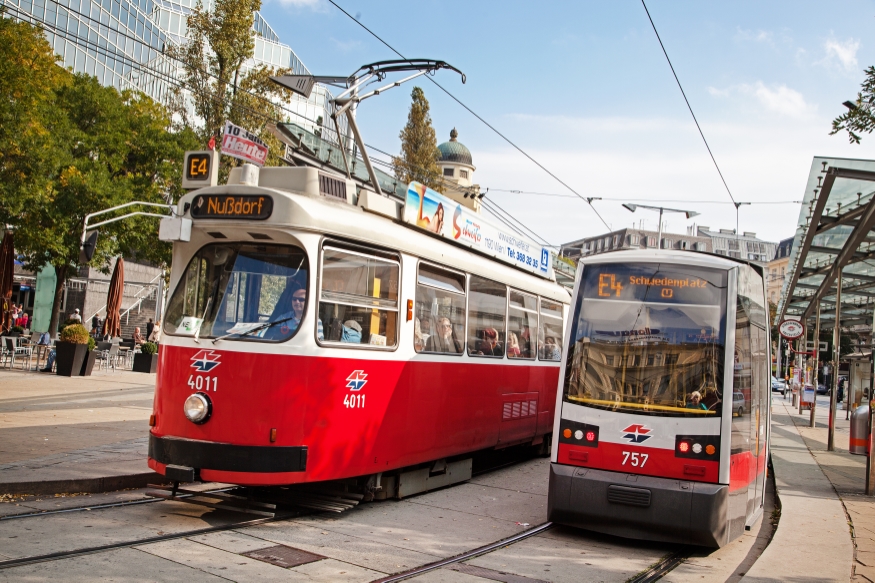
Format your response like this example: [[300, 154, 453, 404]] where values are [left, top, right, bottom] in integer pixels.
[[468, 275, 507, 357]]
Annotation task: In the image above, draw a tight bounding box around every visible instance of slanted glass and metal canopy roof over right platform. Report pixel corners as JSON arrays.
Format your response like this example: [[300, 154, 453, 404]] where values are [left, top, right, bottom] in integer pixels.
[[778, 157, 875, 329]]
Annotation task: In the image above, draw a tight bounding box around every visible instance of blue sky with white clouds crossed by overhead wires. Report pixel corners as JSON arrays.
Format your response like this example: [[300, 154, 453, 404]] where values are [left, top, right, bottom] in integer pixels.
[[262, 0, 875, 244]]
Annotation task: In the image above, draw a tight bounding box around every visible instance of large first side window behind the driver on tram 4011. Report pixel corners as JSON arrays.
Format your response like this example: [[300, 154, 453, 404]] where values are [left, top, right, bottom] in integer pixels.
[[318, 246, 400, 346]]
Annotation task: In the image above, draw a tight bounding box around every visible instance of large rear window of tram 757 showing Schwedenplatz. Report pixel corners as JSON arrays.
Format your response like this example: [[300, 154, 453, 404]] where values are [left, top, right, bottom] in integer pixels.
[[564, 263, 731, 417]]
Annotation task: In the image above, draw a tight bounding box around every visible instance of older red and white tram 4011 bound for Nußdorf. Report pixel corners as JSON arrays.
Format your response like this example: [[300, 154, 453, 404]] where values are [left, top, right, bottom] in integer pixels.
[[149, 166, 570, 495]]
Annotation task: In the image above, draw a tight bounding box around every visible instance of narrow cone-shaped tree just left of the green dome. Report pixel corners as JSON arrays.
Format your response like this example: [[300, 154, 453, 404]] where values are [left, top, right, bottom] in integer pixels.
[[392, 87, 442, 192]]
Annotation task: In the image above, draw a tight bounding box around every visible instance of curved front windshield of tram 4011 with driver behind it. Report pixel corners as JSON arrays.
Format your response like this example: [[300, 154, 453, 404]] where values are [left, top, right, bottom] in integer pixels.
[[164, 243, 309, 342]]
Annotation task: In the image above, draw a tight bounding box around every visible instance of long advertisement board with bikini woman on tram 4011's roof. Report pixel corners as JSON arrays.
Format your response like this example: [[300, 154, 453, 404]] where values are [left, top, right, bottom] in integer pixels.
[[404, 182, 553, 277]]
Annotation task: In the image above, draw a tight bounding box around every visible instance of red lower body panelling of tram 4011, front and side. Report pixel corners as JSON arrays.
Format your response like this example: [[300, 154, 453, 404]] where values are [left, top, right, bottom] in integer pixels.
[[149, 343, 559, 485]]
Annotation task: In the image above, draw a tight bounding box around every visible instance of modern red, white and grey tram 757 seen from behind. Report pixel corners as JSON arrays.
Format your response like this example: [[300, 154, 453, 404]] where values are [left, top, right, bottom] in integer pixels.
[[549, 250, 771, 547]]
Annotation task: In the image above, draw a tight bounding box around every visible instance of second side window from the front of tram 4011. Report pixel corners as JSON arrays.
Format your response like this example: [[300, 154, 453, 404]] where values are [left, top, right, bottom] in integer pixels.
[[413, 263, 465, 354]]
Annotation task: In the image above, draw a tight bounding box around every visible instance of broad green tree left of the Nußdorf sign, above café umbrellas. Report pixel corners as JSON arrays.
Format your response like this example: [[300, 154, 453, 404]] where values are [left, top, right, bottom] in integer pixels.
[[11, 74, 196, 330]]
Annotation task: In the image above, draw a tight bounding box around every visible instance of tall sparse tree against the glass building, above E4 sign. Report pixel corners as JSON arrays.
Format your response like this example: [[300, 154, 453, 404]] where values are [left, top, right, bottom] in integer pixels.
[[167, 0, 291, 174]]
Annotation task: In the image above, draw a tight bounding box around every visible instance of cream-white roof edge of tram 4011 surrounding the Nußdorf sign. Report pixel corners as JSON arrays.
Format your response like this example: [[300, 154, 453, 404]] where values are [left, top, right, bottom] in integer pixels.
[[178, 168, 570, 303]]
